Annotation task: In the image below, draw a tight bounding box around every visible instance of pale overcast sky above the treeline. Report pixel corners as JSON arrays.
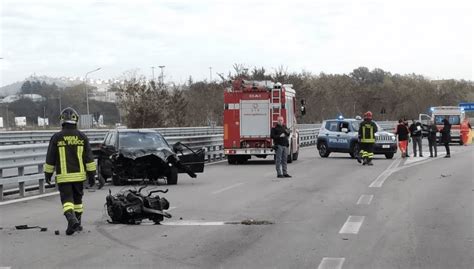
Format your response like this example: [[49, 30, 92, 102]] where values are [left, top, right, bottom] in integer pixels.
[[0, 0, 474, 87]]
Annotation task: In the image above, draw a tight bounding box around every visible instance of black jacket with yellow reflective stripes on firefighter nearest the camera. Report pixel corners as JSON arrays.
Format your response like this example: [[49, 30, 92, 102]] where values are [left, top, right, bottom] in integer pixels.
[[44, 125, 96, 183]]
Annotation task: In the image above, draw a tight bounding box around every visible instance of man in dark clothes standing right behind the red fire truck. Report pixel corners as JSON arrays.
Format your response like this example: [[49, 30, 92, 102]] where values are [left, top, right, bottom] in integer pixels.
[[271, 116, 291, 178]]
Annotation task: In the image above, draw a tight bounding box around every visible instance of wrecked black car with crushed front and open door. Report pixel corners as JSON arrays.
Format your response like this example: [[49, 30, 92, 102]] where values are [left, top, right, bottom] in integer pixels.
[[94, 129, 205, 185]]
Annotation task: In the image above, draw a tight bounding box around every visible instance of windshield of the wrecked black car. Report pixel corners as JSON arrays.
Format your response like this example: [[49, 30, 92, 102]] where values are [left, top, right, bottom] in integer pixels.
[[119, 132, 169, 149]]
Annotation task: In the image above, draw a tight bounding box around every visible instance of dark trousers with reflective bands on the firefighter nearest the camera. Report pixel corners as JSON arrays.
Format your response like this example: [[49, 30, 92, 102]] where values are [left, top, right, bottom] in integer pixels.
[[58, 181, 84, 213]]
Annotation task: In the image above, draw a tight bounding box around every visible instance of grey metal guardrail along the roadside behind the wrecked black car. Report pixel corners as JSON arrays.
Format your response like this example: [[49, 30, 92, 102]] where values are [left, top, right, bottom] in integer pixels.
[[0, 122, 402, 201]]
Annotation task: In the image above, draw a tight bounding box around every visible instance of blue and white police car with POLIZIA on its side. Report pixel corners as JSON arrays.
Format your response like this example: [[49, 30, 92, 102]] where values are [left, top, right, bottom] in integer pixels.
[[317, 117, 397, 159]]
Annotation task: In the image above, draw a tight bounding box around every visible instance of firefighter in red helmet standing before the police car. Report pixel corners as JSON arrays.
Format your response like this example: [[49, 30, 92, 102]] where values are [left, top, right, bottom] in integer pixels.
[[357, 111, 377, 165]]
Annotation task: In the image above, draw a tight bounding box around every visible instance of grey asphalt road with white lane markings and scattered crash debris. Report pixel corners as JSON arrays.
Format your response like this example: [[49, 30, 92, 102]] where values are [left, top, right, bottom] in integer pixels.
[[0, 146, 474, 268]]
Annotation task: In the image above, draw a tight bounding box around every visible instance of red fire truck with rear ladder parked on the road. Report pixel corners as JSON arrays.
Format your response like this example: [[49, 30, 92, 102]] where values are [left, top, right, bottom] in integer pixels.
[[224, 79, 299, 164]]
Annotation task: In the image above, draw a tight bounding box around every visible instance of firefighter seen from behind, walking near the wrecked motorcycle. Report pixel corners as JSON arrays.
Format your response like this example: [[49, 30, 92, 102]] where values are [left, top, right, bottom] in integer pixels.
[[44, 107, 96, 235]]
